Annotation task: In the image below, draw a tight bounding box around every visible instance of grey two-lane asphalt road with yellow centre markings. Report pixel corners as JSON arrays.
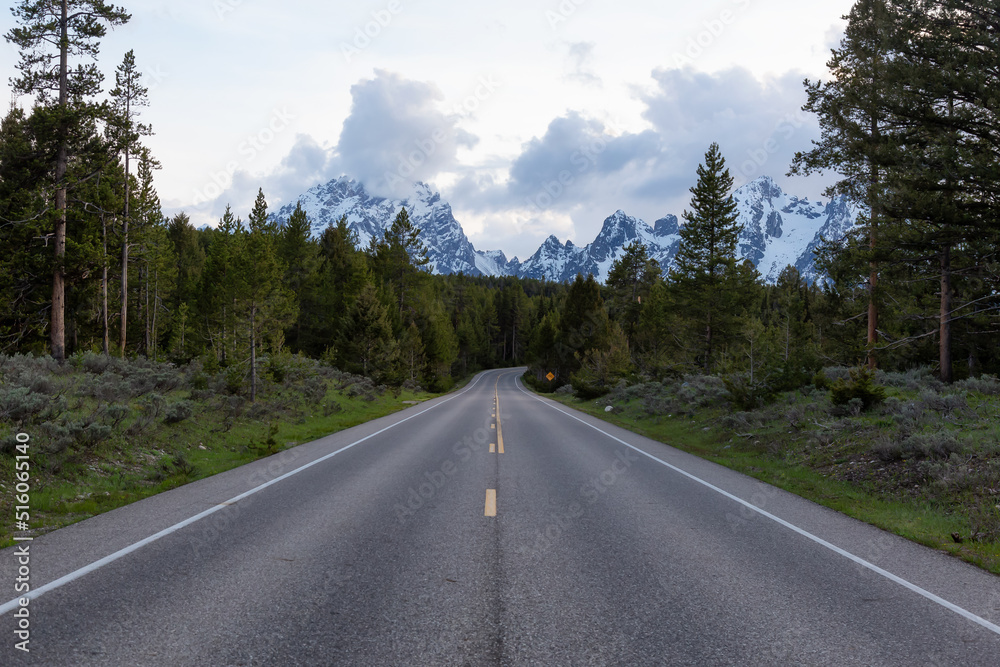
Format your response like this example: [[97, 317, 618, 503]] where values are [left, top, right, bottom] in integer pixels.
[[0, 370, 1000, 666]]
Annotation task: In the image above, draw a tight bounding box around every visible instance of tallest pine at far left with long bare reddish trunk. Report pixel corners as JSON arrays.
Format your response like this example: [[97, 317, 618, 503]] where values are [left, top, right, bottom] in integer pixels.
[[5, 0, 130, 361]]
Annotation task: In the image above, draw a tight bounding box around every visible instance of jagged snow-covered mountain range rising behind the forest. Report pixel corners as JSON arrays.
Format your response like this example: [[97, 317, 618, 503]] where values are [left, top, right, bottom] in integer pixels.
[[275, 176, 857, 283]]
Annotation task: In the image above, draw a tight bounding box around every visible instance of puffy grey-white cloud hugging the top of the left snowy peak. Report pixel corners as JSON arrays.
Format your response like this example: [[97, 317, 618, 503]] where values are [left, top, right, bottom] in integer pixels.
[[337, 70, 477, 196]]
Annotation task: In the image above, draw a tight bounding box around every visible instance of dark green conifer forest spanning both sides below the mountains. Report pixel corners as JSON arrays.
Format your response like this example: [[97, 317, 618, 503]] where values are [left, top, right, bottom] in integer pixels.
[[0, 0, 1000, 405]]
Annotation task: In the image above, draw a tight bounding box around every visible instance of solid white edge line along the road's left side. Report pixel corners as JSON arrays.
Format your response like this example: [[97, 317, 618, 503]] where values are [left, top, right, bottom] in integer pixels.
[[0, 373, 486, 615]]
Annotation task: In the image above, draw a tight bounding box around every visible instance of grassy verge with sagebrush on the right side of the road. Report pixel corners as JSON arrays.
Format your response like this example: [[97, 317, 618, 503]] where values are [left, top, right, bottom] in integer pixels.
[[554, 376, 1000, 574]]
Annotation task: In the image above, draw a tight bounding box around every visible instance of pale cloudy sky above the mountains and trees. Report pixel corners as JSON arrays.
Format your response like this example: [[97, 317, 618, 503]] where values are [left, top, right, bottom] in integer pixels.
[[0, 0, 853, 259]]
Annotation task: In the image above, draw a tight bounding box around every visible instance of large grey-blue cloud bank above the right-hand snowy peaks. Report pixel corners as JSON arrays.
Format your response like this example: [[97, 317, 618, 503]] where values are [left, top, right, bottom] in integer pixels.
[[454, 68, 827, 255]]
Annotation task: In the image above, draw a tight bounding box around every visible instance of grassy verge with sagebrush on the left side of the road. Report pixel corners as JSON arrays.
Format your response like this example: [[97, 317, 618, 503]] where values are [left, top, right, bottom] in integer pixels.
[[0, 355, 436, 547]]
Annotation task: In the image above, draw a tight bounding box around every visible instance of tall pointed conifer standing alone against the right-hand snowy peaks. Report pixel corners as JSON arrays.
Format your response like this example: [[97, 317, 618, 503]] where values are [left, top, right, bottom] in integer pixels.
[[669, 143, 739, 371]]
